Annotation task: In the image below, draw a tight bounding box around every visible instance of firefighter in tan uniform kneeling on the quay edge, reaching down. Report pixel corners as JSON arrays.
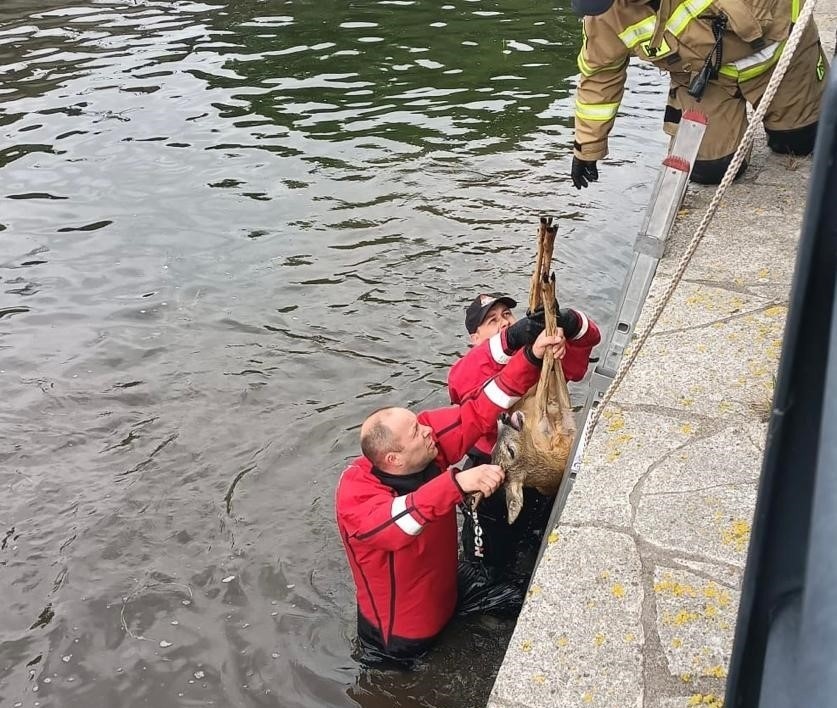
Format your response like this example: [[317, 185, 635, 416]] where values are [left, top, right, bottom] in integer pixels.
[[572, 0, 828, 189]]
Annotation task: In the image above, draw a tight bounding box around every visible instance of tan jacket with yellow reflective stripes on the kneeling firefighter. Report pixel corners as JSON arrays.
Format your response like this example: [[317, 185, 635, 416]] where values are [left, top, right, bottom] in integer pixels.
[[574, 0, 804, 160]]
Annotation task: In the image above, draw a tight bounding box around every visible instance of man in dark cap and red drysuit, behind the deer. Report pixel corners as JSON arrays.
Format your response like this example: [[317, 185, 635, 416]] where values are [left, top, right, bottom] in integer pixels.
[[448, 293, 601, 577]]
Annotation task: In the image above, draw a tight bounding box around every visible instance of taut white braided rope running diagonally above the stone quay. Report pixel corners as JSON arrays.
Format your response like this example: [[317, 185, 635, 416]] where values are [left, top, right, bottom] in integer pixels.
[[582, 0, 817, 450]]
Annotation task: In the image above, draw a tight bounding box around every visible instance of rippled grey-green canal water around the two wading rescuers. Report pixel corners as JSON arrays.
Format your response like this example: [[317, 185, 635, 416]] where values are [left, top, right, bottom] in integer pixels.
[[0, 0, 664, 708]]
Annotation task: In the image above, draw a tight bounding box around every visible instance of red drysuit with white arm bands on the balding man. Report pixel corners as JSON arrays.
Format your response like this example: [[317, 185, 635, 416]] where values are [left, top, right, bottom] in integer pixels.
[[335, 348, 541, 657]]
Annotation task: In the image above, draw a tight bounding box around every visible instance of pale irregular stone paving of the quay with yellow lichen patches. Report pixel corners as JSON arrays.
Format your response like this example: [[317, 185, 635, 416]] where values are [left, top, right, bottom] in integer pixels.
[[489, 8, 837, 708]]
